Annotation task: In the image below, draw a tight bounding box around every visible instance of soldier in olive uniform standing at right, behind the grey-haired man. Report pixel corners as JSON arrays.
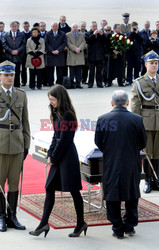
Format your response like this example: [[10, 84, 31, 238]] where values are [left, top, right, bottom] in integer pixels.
[[131, 50, 159, 193]]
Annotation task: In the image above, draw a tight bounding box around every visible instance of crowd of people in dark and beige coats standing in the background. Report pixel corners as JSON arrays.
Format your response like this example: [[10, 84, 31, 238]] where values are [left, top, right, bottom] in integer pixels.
[[0, 13, 159, 90]]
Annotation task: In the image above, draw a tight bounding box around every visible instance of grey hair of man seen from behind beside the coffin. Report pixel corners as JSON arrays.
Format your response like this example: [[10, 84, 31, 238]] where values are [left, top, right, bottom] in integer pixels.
[[112, 90, 128, 107]]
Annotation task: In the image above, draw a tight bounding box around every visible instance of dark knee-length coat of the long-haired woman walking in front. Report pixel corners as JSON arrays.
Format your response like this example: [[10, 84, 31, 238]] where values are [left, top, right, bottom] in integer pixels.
[[46, 114, 82, 191]]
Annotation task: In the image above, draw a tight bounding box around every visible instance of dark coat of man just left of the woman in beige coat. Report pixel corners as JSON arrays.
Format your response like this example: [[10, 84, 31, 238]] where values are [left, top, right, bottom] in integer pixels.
[[3, 31, 26, 63]]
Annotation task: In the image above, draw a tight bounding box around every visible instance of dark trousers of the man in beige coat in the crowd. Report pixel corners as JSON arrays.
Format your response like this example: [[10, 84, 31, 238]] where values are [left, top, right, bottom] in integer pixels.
[[69, 65, 82, 86]]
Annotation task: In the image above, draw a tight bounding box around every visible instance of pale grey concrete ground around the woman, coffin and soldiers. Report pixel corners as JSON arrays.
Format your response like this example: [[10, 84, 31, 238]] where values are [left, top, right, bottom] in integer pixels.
[[0, 83, 159, 250]]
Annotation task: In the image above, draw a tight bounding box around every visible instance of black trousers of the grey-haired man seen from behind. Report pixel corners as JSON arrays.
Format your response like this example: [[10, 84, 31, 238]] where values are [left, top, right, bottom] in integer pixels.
[[106, 199, 138, 236]]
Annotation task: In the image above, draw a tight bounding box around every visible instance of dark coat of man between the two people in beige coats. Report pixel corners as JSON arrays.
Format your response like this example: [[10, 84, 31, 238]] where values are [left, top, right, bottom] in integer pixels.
[[45, 30, 67, 66]]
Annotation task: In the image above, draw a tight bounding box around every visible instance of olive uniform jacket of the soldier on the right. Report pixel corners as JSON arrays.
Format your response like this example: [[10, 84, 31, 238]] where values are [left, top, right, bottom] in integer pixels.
[[131, 73, 159, 131]]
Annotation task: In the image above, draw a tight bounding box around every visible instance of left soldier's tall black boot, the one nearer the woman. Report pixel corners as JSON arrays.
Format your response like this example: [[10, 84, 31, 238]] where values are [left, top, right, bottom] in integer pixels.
[[7, 191, 26, 230]]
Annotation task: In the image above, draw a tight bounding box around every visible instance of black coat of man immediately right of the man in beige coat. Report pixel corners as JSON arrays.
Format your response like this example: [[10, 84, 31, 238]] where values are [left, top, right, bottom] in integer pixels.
[[85, 30, 107, 62]]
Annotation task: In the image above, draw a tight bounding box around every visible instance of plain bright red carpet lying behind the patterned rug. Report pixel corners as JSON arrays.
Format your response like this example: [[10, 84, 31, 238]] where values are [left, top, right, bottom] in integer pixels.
[[17, 155, 99, 194]]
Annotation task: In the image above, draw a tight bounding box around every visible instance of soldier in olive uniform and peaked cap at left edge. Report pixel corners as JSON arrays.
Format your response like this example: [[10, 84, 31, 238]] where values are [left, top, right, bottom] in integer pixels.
[[0, 61, 30, 232]]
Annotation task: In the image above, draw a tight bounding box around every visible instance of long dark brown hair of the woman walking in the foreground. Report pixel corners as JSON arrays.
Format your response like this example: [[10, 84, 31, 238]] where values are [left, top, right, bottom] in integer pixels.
[[48, 84, 77, 125]]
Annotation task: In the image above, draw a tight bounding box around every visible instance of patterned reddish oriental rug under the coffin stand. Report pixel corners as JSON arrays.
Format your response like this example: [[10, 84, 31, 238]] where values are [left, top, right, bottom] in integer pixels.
[[21, 192, 159, 229]]
